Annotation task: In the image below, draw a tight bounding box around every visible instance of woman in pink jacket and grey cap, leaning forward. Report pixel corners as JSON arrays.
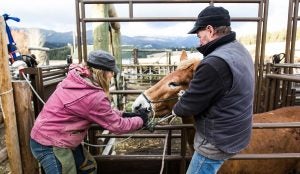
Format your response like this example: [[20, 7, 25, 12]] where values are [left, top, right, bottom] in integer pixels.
[[30, 51, 148, 174]]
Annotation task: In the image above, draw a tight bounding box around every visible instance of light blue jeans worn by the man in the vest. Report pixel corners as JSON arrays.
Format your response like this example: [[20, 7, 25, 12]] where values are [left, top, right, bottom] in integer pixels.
[[186, 152, 224, 174]]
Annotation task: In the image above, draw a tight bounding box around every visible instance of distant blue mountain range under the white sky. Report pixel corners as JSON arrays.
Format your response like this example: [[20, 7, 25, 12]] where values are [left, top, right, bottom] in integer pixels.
[[19, 29, 198, 49]]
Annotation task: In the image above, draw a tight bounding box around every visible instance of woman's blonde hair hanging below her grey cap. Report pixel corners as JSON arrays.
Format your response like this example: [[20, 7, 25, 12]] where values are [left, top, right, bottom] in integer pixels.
[[89, 67, 110, 96]]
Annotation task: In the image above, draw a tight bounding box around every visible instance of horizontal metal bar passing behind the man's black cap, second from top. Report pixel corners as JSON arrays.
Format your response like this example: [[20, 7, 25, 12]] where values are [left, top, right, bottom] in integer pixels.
[[82, 17, 261, 23]]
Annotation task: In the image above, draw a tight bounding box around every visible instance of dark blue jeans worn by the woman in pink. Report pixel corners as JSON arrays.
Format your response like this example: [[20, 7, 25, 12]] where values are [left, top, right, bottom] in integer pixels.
[[30, 139, 84, 174]]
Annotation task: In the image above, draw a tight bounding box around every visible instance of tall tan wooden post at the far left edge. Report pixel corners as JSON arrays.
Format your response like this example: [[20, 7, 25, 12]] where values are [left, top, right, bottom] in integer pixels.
[[0, 16, 22, 174]]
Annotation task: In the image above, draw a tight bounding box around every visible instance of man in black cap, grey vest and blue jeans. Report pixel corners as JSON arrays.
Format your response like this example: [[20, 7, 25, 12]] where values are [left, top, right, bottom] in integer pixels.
[[173, 6, 254, 174]]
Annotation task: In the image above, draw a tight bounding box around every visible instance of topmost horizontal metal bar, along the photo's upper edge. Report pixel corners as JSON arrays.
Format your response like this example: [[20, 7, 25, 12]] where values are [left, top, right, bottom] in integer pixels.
[[81, 0, 263, 4]]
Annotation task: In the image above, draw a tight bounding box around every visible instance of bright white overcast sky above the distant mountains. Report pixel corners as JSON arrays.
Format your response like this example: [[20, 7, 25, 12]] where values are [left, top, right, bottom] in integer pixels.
[[0, 0, 289, 36]]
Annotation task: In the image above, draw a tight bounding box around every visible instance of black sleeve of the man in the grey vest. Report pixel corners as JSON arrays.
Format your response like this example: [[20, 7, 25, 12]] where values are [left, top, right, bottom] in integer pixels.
[[173, 57, 232, 117]]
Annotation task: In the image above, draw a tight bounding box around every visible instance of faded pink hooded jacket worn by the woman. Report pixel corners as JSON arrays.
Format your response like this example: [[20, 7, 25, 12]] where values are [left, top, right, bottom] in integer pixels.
[[30, 68, 143, 148]]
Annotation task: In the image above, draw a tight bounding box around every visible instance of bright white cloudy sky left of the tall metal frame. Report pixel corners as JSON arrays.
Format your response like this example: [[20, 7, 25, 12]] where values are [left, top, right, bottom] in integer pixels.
[[0, 0, 75, 31]]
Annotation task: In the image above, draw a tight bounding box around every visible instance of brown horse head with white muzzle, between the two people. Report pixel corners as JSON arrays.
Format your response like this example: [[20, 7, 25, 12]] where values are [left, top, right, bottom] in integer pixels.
[[132, 55, 200, 116]]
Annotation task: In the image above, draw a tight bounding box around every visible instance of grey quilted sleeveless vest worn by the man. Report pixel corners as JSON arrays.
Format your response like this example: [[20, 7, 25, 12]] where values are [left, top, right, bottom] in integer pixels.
[[196, 41, 254, 153]]
